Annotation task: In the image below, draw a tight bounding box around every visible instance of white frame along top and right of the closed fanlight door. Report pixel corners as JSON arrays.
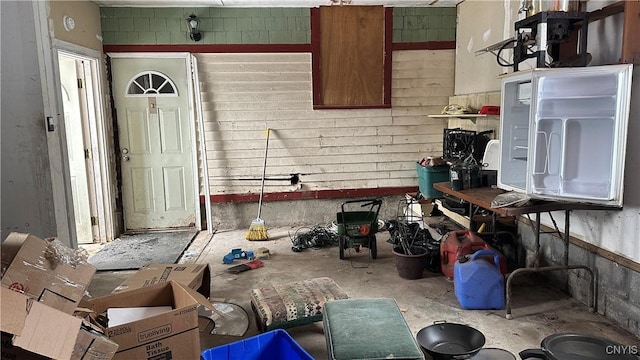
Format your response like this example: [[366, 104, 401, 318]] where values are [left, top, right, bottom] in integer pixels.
[[105, 52, 202, 230]]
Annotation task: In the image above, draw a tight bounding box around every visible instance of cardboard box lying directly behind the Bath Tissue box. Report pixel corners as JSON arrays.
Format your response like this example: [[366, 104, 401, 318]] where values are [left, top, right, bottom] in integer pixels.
[[113, 264, 211, 299]]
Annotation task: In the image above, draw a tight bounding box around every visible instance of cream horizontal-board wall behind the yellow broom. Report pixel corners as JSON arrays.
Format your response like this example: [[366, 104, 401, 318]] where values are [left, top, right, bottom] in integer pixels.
[[192, 50, 454, 194]]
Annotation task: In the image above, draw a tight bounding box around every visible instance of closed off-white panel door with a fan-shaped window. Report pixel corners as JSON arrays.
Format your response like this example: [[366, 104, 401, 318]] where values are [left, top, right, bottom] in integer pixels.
[[111, 58, 196, 231]]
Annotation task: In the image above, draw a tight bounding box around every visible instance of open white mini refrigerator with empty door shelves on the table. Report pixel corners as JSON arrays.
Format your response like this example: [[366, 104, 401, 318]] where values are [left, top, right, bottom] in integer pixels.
[[498, 65, 633, 207]]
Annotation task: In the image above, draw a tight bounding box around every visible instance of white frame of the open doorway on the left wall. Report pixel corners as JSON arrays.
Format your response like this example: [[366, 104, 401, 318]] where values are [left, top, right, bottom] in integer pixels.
[[33, 1, 115, 249]]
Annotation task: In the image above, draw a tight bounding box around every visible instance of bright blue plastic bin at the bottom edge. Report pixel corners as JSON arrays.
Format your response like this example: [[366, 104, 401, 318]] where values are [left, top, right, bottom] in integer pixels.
[[200, 329, 313, 360]]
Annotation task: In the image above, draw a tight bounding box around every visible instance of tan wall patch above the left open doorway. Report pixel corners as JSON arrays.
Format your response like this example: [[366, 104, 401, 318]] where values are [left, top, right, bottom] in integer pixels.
[[49, 0, 102, 51]]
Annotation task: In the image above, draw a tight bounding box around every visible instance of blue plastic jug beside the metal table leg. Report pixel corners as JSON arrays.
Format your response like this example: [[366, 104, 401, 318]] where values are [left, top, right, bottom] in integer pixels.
[[453, 250, 504, 310]]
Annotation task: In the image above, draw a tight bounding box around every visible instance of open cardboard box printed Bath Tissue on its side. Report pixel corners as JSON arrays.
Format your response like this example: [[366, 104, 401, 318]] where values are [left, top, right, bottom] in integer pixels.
[[88, 281, 216, 360]]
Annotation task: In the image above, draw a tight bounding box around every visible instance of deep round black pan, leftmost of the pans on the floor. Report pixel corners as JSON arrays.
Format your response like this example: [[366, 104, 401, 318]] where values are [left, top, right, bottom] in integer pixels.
[[416, 322, 485, 360]]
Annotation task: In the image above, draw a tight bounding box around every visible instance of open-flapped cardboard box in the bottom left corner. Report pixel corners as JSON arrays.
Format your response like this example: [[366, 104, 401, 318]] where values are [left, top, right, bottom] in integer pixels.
[[0, 288, 118, 360]]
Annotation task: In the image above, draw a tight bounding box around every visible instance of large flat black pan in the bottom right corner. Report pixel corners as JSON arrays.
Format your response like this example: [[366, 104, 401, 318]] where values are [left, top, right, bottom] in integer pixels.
[[520, 333, 640, 360]]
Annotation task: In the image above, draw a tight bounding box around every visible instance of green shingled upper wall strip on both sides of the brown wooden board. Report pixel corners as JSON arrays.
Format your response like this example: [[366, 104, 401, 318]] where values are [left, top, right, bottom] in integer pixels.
[[100, 7, 456, 45]]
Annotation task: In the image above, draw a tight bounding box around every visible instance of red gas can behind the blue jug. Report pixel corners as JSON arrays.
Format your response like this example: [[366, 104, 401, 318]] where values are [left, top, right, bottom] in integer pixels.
[[440, 230, 489, 280]]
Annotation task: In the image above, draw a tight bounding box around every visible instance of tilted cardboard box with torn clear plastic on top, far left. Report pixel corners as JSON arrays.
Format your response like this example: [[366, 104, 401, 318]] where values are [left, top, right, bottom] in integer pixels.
[[0, 232, 96, 314]]
